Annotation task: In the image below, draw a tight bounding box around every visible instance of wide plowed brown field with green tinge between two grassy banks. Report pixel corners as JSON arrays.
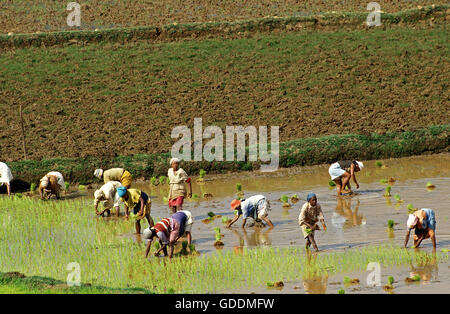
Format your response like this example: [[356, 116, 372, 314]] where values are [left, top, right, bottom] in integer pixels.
[[0, 28, 450, 161]]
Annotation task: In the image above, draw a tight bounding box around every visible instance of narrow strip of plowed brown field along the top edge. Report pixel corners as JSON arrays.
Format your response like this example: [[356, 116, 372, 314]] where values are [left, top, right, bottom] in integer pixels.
[[0, 0, 445, 33]]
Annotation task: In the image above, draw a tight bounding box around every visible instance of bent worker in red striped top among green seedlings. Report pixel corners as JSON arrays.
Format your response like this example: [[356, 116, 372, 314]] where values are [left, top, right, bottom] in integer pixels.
[[143, 210, 194, 258]]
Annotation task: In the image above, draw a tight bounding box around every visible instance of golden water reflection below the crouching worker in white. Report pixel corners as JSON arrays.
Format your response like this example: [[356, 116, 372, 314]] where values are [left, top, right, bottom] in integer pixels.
[[331, 197, 366, 229]]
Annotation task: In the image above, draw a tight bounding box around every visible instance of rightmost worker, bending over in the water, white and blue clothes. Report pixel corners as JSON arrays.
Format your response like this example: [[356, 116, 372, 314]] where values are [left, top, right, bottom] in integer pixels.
[[405, 208, 436, 248]]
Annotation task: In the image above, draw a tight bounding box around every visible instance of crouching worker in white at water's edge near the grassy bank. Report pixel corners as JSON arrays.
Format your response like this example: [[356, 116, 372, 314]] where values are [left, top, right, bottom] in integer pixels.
[[328, 160, 364, 195]]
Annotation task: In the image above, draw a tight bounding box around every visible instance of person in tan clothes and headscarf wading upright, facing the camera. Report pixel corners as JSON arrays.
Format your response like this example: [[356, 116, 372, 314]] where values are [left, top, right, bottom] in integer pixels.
[[298, 193, 327, 252]]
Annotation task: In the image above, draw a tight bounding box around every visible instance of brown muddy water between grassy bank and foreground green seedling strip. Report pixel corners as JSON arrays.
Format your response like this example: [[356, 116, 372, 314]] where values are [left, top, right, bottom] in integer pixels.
[[124, 154, 450, 253]]
